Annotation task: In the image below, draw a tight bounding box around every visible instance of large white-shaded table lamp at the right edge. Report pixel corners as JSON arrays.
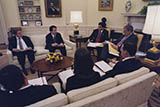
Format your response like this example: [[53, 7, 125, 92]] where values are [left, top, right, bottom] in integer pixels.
[[143, 5, 160, 60]]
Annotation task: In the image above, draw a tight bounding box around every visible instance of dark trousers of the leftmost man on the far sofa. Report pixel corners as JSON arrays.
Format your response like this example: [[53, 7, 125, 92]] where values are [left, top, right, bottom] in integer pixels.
[[13, 50, 35, 71]]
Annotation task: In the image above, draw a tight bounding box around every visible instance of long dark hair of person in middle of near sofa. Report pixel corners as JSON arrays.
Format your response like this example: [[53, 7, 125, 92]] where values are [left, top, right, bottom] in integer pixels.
[[74, 48, 94, 76]]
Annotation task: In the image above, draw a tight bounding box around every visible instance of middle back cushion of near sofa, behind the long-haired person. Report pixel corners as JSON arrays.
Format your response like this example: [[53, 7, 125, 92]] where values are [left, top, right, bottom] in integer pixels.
[[67, 78, 117, 103]]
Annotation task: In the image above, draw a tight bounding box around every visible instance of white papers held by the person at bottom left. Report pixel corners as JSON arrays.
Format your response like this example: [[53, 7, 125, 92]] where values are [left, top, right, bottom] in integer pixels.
[[28, 77, 48, 85]]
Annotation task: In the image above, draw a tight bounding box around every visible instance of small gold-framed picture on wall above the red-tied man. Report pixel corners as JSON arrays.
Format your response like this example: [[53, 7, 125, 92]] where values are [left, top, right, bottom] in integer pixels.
[[98, 0, 113, 11]]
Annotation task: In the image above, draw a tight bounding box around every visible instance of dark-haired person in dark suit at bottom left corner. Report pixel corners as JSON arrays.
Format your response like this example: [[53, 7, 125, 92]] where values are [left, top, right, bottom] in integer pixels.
[[0, 65, 57, 107]]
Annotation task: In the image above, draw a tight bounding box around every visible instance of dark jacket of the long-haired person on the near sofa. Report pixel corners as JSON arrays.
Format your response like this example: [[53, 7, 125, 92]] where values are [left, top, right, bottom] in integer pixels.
[[66, 71, 101, 92]]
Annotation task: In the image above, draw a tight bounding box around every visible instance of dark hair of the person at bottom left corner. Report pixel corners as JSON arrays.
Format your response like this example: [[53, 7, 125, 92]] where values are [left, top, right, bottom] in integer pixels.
[[0, 65, 25, 91]]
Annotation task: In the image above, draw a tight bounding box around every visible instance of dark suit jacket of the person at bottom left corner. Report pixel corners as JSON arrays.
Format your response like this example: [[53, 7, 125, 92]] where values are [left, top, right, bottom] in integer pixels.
[[0, 85, 57, 107]]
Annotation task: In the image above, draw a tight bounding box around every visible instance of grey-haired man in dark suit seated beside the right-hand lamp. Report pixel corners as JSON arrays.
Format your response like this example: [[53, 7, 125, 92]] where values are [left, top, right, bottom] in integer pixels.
[[100, 24, 138, 60]]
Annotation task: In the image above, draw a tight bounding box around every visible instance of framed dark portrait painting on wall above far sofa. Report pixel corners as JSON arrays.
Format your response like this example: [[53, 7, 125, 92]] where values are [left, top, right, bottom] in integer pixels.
[[45, 0, 62, 17]]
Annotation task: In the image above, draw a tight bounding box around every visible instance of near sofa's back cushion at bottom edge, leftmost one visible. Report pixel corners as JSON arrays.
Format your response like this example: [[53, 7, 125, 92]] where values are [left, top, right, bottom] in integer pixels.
[[29, 94, 68, 107]]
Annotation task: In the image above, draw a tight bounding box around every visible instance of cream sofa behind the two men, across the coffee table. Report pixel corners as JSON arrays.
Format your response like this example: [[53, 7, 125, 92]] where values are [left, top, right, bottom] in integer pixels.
[[7, 34, 76, 67]]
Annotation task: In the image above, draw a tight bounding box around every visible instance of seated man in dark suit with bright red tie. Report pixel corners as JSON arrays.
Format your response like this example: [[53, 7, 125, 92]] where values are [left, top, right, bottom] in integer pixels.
[[88, 22, 109, 60]]
